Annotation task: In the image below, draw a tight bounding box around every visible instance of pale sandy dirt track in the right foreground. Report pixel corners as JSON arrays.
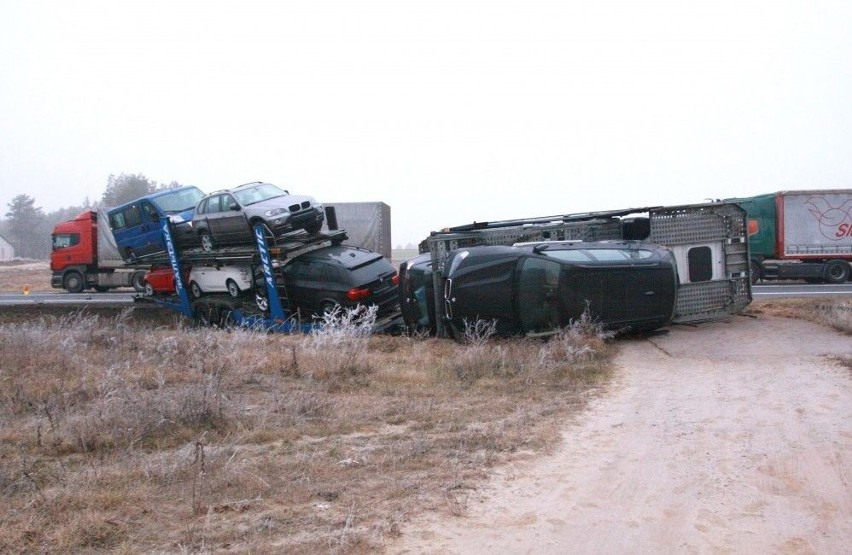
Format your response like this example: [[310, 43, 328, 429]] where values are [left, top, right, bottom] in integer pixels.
[[389, 316, 852, 554]]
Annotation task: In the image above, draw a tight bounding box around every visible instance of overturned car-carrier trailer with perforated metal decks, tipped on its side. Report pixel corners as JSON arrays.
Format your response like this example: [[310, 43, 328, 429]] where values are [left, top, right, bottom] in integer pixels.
[[420, 203, 752, 335]]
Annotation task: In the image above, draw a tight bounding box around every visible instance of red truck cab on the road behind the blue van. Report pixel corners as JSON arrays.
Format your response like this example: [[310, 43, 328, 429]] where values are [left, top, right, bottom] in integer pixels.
[[50, 210, 145, 293]]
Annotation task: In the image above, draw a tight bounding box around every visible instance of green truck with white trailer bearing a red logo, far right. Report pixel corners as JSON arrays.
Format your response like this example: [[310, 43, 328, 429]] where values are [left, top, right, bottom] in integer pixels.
[[726, 189, 852, 283]]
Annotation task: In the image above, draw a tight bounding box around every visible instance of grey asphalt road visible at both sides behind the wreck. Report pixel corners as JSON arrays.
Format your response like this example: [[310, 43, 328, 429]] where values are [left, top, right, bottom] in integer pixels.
[[0, 282, 852, 306]]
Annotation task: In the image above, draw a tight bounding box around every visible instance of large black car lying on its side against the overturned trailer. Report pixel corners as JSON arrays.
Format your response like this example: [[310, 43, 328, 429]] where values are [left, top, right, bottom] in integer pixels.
[[406, 241, 678, 337]]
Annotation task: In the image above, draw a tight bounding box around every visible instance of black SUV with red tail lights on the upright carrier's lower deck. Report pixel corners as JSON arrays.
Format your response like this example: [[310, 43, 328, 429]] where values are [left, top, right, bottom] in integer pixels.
[[255, 245, 399, 319]]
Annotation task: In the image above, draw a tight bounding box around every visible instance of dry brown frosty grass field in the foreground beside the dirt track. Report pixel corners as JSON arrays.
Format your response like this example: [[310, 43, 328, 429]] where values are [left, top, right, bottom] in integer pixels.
[[0, 312, 611, 553]]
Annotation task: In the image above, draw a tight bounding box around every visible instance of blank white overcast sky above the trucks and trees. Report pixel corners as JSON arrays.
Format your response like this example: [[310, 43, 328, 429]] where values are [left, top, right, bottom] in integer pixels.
[[0, 0, 852, 245]]
